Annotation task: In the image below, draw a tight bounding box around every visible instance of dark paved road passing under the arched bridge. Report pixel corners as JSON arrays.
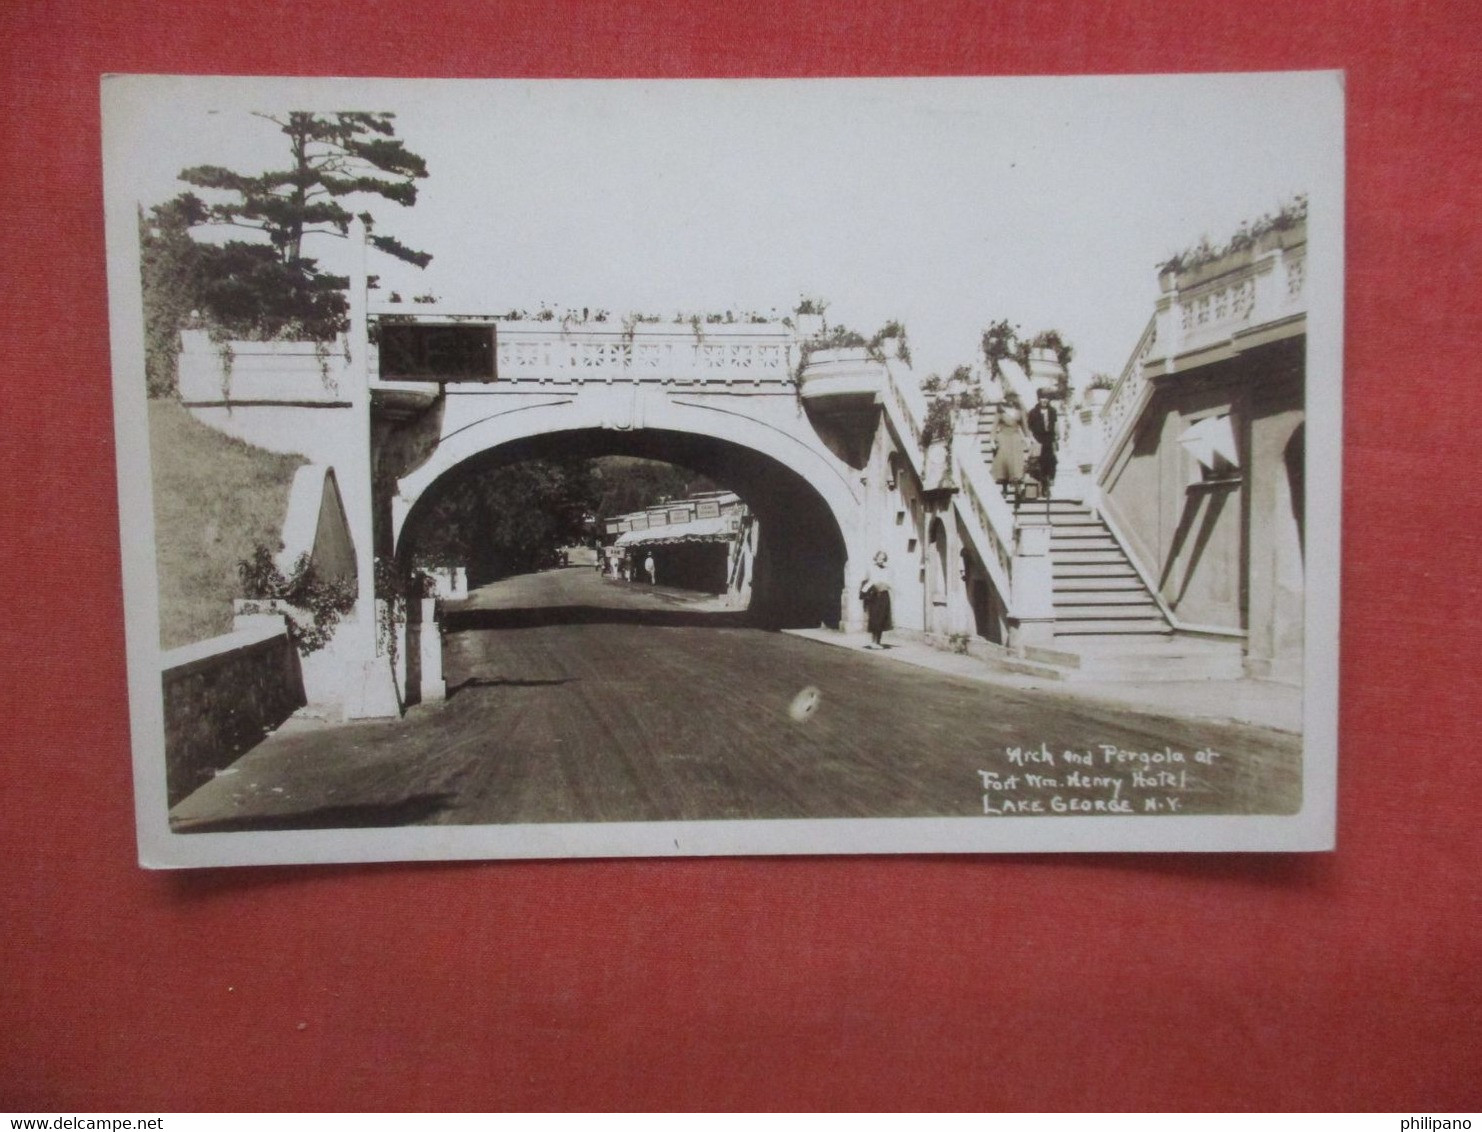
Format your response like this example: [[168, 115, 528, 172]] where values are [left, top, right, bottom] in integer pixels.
[[172, 569, 1301, 830]]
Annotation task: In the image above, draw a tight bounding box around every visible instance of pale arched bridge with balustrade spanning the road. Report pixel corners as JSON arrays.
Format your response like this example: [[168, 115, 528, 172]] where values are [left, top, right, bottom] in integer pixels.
[[371, 308, 879, 625]]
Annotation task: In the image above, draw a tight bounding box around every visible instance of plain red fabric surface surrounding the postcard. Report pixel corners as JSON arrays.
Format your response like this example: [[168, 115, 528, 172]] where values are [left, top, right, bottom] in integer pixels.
[[0, 0, 1482, 1111]]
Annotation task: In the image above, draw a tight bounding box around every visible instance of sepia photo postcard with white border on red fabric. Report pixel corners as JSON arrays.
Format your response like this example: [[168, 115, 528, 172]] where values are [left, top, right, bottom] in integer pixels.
[[102, 73, 1344, 868]]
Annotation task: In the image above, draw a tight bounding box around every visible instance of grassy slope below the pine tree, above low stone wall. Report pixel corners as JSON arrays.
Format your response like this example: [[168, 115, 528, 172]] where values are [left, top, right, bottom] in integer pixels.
[[150, 400, 305, 649]]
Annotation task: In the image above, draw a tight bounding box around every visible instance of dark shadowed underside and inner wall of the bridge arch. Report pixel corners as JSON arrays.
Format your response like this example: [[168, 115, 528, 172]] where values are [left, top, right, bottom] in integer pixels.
[[397, 428, 845, 628]]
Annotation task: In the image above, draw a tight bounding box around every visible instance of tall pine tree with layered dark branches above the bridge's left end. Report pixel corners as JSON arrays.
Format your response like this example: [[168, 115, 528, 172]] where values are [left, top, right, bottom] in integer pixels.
[[153, 111, 431, 346]]
